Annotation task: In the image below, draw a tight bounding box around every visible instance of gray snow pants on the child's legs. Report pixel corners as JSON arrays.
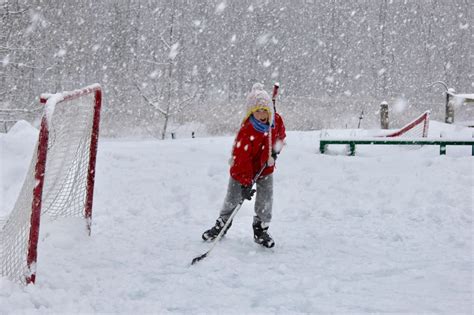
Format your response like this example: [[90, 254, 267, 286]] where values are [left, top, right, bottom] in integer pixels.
[[219, 174, 273, 223]]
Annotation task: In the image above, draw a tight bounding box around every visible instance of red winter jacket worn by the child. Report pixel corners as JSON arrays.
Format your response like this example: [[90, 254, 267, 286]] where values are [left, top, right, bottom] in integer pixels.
[[230, 114, 286, 186]]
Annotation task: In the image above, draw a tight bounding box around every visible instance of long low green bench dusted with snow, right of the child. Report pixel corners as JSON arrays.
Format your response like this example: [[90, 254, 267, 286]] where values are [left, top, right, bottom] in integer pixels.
[[319, 138, 474, 156]]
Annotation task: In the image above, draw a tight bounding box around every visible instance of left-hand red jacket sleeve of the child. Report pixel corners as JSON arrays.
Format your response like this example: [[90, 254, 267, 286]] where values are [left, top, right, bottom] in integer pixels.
[[230, 127, 253, 186]]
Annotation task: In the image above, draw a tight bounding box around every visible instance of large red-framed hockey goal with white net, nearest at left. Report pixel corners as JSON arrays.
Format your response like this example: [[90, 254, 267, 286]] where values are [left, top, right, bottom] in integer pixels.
[[0, 84, 102, 284]]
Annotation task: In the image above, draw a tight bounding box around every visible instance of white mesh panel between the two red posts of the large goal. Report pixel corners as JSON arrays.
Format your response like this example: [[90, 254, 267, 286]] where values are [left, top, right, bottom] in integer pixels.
[[42, 94, 94, 216]]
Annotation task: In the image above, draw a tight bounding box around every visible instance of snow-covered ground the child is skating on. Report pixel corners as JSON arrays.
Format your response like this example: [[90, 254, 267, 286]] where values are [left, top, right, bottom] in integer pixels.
[[0, 122, 474, 315]]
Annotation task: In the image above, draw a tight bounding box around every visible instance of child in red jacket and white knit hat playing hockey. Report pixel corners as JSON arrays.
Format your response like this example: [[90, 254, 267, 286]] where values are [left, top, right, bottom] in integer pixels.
[[202, 83, 286, 248]]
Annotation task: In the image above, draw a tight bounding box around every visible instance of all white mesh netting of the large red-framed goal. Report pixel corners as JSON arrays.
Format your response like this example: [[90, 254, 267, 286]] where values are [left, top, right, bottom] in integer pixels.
[[0, 87, 96, 283]]
